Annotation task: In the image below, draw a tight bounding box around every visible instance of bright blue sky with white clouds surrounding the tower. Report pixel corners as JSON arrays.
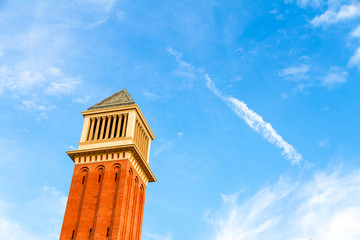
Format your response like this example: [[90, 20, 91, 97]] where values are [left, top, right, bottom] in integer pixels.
[[0, 0, 360, 240]]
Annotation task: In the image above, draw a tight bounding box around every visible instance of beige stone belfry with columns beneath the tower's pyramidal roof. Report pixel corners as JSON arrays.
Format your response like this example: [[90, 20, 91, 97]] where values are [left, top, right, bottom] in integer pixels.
[[78, 104, 155, 163]]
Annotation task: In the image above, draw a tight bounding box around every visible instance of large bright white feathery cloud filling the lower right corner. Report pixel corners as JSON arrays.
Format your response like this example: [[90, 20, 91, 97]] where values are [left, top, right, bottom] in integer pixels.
[[206, 169, 360, 240]]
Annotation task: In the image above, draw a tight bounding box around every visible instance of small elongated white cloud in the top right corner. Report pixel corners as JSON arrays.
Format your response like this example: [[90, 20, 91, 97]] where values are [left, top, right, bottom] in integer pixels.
[[311, 3, 360, 26]]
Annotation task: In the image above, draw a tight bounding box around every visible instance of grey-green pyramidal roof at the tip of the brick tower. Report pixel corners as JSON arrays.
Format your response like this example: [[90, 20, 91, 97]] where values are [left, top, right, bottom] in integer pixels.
[[88, 88, 135, 110]]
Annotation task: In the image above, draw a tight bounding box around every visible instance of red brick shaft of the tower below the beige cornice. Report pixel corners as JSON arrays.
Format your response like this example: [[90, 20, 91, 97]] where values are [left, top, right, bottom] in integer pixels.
[[60, 159, 146, 240]]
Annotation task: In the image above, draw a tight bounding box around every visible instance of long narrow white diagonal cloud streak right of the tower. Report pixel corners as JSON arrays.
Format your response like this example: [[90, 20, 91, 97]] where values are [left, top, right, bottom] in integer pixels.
[[205, 74, 302, 164]]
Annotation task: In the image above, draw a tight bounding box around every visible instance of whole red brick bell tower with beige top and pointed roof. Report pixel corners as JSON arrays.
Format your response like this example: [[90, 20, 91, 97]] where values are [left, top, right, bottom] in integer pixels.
[[60, 89, 156, 240]]
